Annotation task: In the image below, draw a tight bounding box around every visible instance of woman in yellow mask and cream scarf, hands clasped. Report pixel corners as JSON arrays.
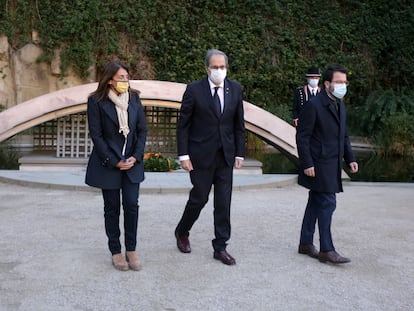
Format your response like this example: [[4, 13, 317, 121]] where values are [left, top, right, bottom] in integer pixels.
[[86, 61, 147, 271]]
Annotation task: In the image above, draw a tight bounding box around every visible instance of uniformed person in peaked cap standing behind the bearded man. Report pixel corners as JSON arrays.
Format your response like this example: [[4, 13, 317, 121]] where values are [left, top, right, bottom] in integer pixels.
[[292, 67, 321, 127]]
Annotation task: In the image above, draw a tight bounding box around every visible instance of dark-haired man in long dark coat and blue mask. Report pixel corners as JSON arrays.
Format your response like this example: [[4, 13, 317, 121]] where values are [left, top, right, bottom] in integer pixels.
[[296, 66, 358, 264]]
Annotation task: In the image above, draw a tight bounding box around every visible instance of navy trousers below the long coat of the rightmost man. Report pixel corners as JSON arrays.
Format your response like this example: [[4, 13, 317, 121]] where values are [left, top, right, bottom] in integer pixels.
[[300, 190, 336, 252]]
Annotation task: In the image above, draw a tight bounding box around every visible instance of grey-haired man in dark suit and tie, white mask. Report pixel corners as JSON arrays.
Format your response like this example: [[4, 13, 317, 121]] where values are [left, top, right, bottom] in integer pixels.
[[175, 49, 245, 265]]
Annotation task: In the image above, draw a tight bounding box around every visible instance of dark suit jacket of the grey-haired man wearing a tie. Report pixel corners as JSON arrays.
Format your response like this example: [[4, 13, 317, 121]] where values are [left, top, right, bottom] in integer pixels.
[[177, 77, 245, 168]]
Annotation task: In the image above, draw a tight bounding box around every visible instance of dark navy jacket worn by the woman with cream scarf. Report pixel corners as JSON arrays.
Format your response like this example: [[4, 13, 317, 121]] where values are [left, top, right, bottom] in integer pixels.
[[85, 91, 147, 189]]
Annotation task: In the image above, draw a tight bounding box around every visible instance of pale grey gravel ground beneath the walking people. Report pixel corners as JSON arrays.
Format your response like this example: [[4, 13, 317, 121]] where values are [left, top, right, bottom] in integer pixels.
[[0, 175, 414, 311]]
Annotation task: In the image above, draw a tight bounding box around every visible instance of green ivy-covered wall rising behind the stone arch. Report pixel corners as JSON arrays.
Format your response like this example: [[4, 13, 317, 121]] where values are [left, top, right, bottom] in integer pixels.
[[0, 0, 414, 152]]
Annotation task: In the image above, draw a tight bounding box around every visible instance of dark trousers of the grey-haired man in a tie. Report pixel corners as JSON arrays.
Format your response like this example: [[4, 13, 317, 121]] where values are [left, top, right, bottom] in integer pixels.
[[176, 149, 233, 251]]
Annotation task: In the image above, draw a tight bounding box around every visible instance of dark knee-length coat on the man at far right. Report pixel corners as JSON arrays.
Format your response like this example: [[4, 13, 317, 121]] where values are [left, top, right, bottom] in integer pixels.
[[296, 90, 355, 193]]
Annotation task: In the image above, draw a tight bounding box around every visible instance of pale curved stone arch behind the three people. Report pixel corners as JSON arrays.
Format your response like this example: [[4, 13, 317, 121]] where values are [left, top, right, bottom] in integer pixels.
[[0, 80, 298, 163]]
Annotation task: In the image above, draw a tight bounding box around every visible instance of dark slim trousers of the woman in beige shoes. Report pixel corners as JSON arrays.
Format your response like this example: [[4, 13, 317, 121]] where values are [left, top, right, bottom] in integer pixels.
[[102, 173, 139, 255]]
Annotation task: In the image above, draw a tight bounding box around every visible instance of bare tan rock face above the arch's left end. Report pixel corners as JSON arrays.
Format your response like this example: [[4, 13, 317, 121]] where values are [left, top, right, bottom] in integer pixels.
[[0, 34, 95, 110]]
